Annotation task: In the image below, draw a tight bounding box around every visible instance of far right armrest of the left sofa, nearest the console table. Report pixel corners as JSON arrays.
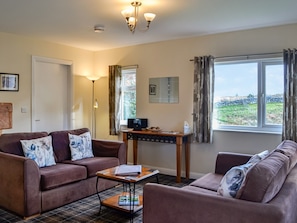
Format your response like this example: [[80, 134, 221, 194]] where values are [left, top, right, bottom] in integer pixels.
[[92, 139, 127, 164]]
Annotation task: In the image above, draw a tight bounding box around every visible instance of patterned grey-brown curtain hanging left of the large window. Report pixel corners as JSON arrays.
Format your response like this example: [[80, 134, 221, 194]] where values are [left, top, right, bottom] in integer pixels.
[[193, 56, 214, 143]]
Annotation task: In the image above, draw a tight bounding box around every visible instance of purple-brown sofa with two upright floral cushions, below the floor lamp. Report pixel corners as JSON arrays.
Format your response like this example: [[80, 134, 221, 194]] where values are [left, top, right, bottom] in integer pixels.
[[0, 128, 127, 219]]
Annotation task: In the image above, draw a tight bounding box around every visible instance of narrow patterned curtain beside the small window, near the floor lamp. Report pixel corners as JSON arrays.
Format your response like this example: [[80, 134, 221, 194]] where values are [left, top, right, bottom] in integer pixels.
[[109, 65, 122, 135]]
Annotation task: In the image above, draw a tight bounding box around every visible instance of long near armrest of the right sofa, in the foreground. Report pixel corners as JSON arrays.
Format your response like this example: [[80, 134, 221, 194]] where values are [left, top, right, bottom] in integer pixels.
[[143, 183, 286, 223]]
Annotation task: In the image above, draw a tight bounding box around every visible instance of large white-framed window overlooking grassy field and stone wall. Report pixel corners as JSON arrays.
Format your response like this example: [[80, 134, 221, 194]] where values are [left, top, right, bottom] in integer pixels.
[[213, 58, 284, 132]]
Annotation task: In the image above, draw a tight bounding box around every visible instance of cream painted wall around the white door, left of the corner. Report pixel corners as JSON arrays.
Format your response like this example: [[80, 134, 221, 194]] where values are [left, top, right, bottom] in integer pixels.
[[0, 33, 94, 133]]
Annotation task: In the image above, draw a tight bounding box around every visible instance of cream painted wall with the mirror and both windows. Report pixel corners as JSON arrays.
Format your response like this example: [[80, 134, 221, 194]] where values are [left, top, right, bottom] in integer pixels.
[[94, 24, 297, 177]]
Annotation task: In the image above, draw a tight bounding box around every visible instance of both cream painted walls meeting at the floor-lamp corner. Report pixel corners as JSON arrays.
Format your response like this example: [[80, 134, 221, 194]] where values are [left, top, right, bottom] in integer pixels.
[[0, 24, 297, 177]]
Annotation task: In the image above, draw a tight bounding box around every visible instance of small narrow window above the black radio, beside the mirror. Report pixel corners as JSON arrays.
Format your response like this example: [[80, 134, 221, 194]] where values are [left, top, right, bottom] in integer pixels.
[[121, 67, 136, 125]]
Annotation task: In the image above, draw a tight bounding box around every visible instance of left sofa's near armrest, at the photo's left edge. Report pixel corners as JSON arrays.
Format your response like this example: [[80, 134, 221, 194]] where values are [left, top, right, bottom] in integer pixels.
[[0, 152, 41, 217]]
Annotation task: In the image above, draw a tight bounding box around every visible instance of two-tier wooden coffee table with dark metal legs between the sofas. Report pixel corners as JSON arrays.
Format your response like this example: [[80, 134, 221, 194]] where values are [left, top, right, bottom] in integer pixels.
[[96, 167, 159, 221]]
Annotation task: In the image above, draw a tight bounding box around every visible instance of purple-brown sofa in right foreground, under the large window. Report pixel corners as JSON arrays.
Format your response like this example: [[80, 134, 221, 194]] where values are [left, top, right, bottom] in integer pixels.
[[143, 140, 297, 223]]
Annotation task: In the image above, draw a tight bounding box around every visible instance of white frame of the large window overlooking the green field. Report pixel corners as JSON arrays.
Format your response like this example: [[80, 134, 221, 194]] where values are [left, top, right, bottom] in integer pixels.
[[213, 54, 283, 134]]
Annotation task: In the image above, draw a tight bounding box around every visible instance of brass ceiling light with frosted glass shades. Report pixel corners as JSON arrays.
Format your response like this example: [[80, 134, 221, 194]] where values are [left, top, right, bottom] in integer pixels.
[[122, 2, 156, 33]]
